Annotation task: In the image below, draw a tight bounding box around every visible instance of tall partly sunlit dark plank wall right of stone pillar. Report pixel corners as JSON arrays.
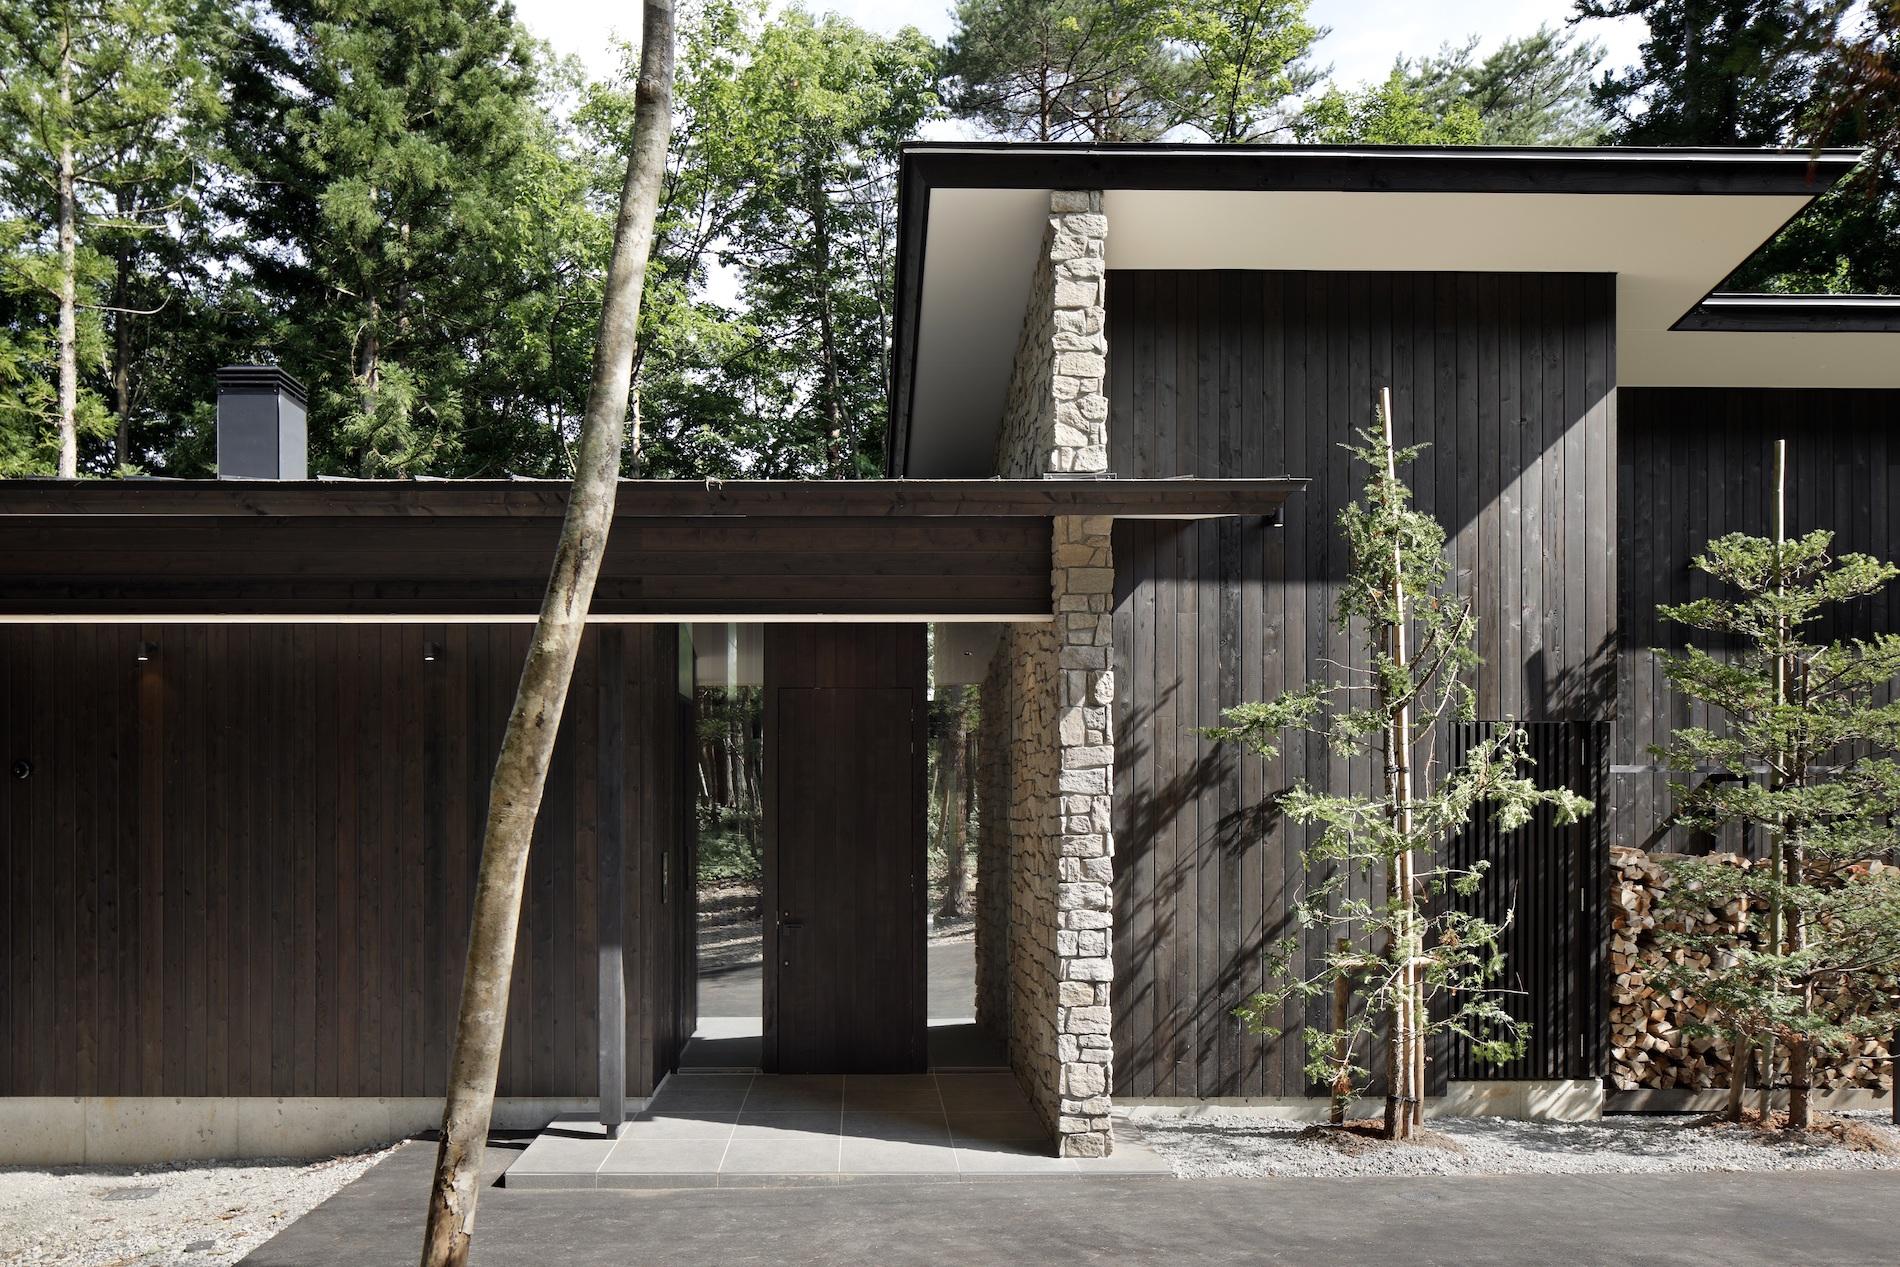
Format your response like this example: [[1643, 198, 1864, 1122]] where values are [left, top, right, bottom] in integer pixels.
[[1108, 272, 1617, 1096]]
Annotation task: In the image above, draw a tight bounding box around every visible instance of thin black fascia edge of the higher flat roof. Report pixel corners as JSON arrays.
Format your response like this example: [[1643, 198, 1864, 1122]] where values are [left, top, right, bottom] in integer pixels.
[[885, 141, 1860, 475]]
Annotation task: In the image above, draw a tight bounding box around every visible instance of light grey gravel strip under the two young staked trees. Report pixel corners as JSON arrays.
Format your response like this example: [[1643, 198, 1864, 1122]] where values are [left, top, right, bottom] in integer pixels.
[[1117, 1106, 1900, 1178]]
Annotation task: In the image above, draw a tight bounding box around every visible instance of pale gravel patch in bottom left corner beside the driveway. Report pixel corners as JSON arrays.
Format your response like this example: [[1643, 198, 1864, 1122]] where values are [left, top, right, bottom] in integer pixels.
[[0, 1149, 391, 1267]]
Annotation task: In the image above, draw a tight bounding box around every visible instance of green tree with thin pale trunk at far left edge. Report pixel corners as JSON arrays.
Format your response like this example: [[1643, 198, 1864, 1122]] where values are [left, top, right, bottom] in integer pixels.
[[0, 0, 219, 479]]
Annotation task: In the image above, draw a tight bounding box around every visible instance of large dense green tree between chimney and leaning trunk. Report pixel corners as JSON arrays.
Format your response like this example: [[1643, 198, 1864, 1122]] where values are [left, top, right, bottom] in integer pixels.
[[224, 0, 577, 475]]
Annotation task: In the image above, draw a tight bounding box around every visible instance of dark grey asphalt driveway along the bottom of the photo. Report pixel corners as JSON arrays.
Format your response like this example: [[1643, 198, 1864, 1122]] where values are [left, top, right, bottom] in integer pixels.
[[245, 1140, 1900, 1267]]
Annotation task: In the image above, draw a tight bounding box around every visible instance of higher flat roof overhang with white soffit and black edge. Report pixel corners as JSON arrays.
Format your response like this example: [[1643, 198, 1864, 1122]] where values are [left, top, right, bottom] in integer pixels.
[[887, 142, 1869, 475]]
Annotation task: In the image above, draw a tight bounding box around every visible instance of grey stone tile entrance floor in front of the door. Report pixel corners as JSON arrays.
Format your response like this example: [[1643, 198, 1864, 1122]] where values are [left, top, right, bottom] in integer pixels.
[[504, 1073, 1170, 1189]]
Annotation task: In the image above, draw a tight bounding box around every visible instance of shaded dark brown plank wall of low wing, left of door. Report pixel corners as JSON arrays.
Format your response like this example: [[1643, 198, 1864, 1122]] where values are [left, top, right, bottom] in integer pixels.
[[0, 625, 684, 1096]]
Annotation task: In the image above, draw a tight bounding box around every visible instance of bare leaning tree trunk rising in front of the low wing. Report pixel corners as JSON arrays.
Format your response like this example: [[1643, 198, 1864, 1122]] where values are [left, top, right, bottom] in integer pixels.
[[422, 0, 673, 1267]]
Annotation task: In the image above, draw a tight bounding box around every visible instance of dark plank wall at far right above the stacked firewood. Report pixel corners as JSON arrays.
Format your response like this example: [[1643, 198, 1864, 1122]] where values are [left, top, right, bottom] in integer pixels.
[[1611, 388, 1900, 849]]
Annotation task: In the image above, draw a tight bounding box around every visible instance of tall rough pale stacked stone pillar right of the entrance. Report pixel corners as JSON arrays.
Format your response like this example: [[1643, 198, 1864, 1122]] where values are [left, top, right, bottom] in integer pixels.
[[979, 190, 1115, 1157]]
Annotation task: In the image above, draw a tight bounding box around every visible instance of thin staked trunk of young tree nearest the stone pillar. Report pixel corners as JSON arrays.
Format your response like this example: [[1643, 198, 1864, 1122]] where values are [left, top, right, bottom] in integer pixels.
[[1379, 388, 1423, 1140]]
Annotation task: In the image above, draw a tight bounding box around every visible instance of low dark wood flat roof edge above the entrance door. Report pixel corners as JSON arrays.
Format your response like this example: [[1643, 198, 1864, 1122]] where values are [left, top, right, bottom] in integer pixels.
[[0, 479, 1305, 623]]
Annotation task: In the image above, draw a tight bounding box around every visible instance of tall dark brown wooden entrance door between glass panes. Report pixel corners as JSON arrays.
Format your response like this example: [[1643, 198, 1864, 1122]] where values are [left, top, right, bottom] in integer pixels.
[[764, 625, 927, 1073]]
